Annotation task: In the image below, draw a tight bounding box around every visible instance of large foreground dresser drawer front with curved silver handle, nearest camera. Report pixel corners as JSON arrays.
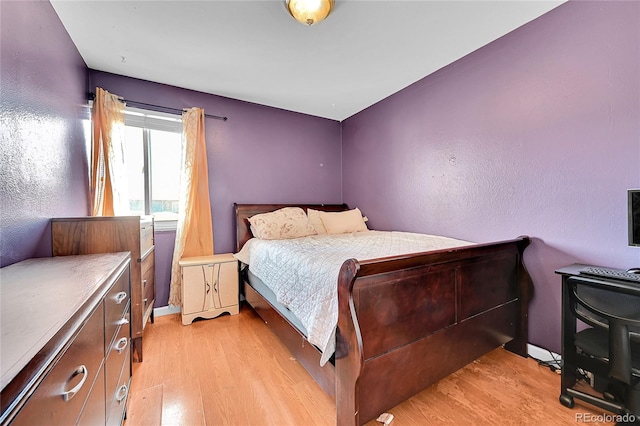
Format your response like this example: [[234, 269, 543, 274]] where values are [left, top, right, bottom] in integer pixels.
[[13, 304, 104, 425]]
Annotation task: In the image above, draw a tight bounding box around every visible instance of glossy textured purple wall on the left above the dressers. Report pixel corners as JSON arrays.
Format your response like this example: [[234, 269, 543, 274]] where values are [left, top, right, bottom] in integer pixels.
[[0, 1, 89, 266]]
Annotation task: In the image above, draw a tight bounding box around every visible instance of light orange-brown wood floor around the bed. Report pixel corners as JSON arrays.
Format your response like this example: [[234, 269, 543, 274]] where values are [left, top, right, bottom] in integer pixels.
[[125, 306, 611, 426]]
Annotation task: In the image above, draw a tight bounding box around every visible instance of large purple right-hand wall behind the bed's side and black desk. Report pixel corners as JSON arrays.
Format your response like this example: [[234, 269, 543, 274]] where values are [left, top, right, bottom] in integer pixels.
[[343, 1, 640, 352]]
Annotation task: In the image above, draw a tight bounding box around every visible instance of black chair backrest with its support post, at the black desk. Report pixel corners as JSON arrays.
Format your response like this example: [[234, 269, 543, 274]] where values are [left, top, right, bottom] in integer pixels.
[[567, 277, 640, 384]]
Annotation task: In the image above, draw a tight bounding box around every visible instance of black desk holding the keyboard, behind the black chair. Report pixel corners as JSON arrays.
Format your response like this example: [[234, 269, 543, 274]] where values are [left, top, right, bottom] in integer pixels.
[[555, 264, 640, 413]]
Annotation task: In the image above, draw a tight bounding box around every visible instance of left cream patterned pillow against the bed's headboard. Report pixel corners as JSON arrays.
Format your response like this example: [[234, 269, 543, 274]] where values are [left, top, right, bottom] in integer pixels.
[[249, 207, 316, 240]]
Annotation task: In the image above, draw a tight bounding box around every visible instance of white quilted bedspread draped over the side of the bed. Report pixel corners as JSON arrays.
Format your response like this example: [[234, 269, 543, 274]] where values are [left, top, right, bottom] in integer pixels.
[[235, 231, 473, 365]]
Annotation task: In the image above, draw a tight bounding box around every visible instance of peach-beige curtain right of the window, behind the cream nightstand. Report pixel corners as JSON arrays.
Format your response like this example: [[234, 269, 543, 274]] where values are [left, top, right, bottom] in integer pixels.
[[169, 108, 213, 306]]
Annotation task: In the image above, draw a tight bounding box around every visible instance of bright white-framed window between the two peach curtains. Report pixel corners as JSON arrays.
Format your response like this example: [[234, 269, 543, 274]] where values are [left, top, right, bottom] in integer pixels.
[[125, 107, 182, 229]]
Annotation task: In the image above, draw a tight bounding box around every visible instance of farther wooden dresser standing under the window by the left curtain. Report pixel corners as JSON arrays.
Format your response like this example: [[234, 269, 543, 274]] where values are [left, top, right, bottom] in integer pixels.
[[51, 216, 156, 361]]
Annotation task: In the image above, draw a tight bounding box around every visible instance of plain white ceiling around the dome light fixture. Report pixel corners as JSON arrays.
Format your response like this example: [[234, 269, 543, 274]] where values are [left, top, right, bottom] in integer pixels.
[[51, 0, 564, 121]]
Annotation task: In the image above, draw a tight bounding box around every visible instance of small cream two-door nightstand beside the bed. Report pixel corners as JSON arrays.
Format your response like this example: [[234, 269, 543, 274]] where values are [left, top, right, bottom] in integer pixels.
[[179, 253, 239, 325]]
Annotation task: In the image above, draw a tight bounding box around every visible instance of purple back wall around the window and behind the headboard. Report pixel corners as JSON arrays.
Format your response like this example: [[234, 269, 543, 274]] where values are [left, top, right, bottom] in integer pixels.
[[90, 71, 342, 306]]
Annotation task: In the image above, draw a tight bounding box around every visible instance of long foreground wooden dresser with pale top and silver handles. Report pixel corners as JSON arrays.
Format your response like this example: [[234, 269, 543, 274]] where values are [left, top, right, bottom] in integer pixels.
[[0, 253, 131, 426]]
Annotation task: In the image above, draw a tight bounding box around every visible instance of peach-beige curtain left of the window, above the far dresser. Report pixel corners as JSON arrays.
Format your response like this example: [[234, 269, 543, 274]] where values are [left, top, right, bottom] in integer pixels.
[[91, 87, 129, 216]]
